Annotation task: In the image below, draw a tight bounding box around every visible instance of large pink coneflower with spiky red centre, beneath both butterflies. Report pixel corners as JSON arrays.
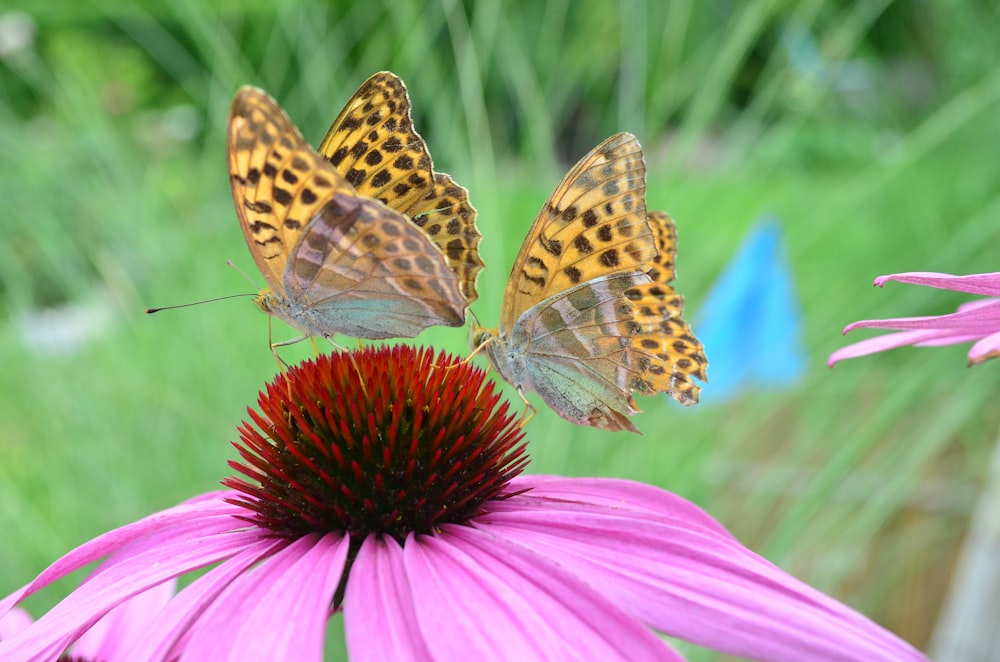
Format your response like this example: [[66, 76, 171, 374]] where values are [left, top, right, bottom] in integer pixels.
[[0, 347, 923, 661]]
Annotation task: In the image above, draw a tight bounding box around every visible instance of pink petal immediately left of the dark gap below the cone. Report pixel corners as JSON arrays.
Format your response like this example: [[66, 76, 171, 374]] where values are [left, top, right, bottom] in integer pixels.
[[184, 533, 348, 662]]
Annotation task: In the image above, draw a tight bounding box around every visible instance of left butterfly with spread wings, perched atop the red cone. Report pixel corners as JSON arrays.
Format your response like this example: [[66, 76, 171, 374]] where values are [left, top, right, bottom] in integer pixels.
[[227, 72, 483, 344]]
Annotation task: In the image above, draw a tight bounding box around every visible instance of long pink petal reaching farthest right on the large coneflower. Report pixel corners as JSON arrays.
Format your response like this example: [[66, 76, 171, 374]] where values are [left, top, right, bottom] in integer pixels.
[[477, 482, 923, 660]]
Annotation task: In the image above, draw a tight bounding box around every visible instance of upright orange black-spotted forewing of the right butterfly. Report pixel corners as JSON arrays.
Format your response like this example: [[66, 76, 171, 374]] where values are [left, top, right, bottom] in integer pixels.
[[500, 133, 656, 333]]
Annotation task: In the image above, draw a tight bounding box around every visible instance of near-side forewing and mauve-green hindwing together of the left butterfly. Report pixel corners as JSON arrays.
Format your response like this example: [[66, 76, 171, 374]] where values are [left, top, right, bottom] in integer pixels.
[[227, 87, 466, 339]]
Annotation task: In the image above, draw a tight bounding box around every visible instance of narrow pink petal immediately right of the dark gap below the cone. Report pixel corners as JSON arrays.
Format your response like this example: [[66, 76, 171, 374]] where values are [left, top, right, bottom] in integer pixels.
[[344, 536, 432, 662]]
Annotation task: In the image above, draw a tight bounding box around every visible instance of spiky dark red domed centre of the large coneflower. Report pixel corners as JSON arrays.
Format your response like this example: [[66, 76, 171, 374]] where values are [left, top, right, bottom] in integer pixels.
[[224, 345, 527, 541]]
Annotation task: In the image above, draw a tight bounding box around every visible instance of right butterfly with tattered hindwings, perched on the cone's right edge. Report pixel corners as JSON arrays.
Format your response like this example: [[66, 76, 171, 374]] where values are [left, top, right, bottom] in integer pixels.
[[471, 133, 697, 432]]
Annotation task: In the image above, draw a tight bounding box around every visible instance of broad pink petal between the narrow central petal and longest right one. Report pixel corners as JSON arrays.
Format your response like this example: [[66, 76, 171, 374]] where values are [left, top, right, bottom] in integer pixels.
[[403, 524, 680, 660]]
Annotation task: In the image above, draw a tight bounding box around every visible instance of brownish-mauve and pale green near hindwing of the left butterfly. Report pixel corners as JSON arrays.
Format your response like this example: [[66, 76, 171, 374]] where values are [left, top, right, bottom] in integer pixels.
[[285, 193, 465, 339]]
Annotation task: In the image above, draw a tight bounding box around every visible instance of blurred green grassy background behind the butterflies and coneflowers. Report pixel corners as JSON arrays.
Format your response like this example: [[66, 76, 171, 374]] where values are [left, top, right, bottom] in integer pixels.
[[0, 0, 1000, 657]]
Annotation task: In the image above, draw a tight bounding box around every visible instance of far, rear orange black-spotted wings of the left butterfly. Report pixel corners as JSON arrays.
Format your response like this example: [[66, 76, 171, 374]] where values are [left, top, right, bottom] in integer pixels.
[[319, 71, 483, 303]]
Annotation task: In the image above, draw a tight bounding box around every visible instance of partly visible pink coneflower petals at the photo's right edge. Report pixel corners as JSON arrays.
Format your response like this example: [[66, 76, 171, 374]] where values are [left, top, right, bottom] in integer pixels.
[[827, 271, 1000, 366]]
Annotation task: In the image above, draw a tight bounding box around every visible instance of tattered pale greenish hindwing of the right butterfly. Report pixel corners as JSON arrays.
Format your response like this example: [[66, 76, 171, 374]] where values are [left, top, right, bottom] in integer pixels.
[[508, 272, 649, 432]]
